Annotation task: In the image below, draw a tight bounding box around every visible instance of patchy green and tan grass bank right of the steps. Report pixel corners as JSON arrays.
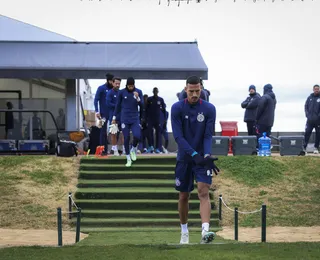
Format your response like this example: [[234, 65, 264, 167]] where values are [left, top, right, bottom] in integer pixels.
[[214, 156, 320, 227]]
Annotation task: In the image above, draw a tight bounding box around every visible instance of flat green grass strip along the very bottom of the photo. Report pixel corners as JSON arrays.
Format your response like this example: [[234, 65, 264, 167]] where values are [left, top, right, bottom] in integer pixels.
[[0, 243, 320, 260]]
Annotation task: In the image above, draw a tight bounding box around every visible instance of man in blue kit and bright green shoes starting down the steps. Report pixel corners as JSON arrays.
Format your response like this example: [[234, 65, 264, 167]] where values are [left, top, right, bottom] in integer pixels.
[[112, 77, 144, 167]]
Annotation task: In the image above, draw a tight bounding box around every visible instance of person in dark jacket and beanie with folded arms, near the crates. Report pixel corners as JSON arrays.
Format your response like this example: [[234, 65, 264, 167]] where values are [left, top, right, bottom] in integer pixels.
[[241, 85, 261, 135]]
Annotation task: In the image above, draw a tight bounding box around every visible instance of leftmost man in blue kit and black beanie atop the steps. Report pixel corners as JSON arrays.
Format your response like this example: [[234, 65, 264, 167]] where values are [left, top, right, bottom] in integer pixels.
[[94, 73, 113, 153]]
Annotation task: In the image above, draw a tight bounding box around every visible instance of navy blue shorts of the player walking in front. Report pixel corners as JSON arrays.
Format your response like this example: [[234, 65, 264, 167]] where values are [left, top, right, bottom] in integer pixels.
[[175, 161, 212, 192]]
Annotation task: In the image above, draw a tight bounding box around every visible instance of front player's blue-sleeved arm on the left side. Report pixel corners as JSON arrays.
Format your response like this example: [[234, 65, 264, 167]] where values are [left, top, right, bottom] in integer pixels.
[[171, 103, 196, 156]]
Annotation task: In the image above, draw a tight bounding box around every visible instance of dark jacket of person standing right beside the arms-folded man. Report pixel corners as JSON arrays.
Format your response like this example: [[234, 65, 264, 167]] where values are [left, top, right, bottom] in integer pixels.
[[256, 89, 277, 127]]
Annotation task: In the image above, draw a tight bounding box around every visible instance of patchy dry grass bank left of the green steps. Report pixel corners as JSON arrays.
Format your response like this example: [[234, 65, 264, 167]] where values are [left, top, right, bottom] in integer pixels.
[[0, 156, 79, 229]]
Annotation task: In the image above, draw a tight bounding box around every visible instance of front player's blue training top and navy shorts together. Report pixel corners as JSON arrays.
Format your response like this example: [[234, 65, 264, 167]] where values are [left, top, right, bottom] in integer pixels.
[[171, 99, 216, 192]]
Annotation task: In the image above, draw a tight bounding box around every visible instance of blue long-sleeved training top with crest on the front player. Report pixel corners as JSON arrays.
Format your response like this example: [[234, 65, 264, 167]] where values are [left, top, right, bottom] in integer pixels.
[[171, 99, 216, 161]]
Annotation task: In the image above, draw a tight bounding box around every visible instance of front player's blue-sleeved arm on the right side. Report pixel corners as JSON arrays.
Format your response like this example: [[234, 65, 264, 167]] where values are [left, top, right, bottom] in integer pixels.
[[203, 105, 216, 157]]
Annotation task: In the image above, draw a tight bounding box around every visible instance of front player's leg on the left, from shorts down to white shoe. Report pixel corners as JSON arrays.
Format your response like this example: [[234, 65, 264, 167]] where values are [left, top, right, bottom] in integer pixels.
[[175, 162, 194, 244]]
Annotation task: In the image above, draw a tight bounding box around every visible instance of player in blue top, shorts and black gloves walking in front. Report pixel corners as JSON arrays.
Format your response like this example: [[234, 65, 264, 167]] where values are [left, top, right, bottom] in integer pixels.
[[171, 76, 219, 244]]
